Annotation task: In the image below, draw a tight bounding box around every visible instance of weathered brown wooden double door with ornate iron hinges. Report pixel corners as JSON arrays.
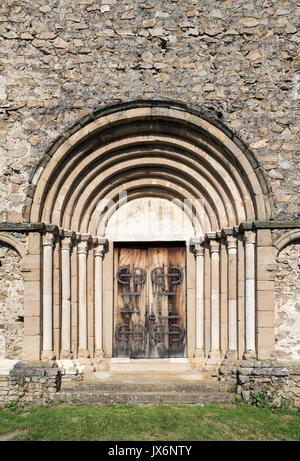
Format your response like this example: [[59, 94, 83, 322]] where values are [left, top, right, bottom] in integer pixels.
[[113, 245, 186, 358]]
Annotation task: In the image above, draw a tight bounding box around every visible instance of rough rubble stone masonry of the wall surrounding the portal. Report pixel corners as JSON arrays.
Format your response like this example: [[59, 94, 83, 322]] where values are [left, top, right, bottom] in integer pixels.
[[0, 0, 300, 402]]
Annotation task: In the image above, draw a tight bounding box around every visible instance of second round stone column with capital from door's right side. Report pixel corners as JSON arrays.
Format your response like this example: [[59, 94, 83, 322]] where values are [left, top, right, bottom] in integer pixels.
[[208, 240, 220, 364]]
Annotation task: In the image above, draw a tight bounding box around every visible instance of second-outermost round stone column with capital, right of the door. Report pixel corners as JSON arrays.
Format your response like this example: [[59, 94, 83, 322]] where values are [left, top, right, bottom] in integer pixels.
[[226, 236, 237, 359]]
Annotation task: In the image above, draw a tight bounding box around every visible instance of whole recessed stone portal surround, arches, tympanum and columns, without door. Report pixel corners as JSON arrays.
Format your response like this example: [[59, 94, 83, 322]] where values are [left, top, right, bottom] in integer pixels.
[[21, 101, 272, 367]]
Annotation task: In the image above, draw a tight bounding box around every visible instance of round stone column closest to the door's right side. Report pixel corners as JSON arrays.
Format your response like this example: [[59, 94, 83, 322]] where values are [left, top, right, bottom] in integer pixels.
[[194, 245, 204, 357]]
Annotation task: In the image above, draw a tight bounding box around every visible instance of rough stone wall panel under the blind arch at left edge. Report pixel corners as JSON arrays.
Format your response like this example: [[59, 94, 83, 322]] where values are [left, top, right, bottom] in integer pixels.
[[0, 242, 24, 359]]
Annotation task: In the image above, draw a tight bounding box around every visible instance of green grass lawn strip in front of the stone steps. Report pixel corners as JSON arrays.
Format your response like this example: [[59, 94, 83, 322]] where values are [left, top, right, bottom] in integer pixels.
[[0, 404, 300, 441]]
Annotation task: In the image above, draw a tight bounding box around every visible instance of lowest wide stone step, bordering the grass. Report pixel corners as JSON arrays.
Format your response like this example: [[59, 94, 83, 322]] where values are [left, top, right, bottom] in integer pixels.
[[52, 390, 236, 406]]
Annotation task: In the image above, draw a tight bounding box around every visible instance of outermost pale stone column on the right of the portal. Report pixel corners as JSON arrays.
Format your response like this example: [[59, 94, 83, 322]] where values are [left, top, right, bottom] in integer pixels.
[[244, 231, 256, 359]]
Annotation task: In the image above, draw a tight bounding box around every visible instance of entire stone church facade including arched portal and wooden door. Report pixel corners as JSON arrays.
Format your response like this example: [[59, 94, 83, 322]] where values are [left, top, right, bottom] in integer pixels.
[[0, 0, 300, 402]]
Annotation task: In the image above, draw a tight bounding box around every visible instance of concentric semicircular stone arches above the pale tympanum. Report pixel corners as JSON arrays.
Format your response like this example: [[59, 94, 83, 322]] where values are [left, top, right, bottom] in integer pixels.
[[25, 101, 272, 235]]
